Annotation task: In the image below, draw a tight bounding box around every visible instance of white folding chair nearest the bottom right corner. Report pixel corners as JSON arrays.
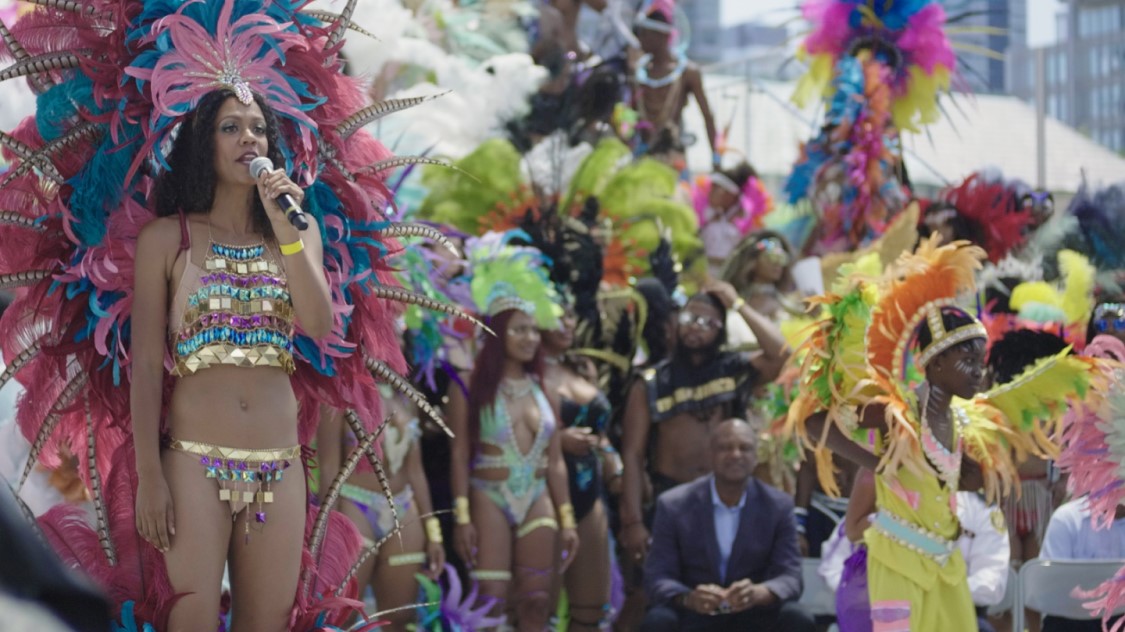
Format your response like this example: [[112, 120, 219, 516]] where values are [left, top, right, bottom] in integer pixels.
[[1013, 558, 1125, 630]]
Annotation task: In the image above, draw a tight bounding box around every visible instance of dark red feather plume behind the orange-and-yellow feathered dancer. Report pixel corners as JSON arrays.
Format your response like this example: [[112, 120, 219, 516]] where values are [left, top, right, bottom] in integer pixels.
[[941, 173, 1033, 263]]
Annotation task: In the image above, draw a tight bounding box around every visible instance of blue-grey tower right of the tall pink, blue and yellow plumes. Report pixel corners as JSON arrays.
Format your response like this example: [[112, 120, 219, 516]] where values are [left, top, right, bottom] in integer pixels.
[[939, 0, 1027, 94]]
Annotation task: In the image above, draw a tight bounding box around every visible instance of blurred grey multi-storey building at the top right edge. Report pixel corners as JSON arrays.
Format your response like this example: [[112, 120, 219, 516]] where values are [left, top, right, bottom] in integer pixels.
[[1009, 0, 1125, 153]]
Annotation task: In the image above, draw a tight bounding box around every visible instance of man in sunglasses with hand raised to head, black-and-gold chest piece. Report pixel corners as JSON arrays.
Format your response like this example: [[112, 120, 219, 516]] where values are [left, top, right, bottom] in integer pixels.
[[621, 281, 789, 560]]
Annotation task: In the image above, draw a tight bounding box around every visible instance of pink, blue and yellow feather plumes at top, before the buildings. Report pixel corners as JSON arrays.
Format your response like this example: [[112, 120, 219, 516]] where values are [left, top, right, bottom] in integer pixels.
[[794, 0, 956, 130]]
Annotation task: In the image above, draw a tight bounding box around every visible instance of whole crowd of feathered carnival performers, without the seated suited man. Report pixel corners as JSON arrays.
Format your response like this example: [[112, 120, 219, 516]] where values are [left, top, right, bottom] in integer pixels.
[[0, 0, 1125, 632]]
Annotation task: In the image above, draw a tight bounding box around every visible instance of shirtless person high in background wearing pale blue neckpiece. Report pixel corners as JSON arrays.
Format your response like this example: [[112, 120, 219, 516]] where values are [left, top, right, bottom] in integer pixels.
[[633, 10, 720, 169]]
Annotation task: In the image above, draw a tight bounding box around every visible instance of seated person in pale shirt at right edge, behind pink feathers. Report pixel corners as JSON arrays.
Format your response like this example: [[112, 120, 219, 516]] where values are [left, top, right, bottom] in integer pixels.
[[1040, 498, 1125, 632]]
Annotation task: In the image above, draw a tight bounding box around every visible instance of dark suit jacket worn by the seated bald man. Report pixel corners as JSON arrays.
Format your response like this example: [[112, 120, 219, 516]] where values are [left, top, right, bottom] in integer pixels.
[[645, 475, 802, 605]]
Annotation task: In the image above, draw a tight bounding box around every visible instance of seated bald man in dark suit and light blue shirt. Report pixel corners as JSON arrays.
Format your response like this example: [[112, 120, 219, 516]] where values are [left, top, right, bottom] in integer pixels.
[[641, 419, 816, 632]]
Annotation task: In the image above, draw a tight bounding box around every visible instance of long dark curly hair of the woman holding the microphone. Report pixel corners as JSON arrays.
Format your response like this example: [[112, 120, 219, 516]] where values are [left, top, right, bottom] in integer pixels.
[[154, 89, 285, 238]]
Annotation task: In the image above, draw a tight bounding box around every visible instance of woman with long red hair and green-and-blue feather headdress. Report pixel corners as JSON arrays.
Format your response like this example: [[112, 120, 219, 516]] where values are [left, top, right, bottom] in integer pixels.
[[448, 234, 578, 631]]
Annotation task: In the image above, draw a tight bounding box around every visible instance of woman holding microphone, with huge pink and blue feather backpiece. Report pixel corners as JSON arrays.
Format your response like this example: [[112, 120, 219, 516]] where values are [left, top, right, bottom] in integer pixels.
[[0, 0, 479, 630]]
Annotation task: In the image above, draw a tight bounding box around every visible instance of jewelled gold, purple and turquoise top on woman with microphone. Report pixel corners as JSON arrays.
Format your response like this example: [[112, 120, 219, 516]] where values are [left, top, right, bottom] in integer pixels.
[[169, 223, 295, 377]]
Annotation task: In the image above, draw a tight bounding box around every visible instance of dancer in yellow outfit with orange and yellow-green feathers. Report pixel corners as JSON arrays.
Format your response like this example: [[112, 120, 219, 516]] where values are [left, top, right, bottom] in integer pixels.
[[790, 236, 1090, 632]]
